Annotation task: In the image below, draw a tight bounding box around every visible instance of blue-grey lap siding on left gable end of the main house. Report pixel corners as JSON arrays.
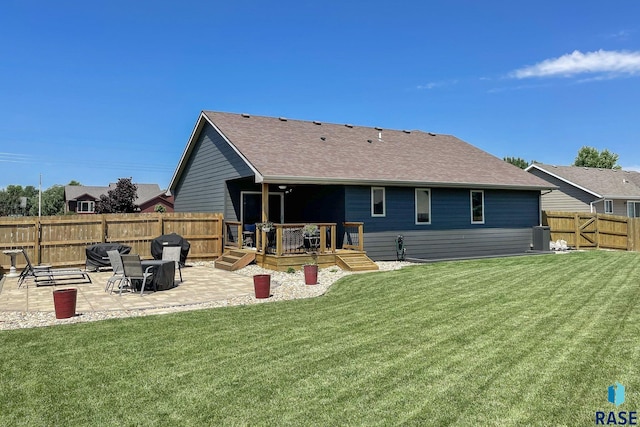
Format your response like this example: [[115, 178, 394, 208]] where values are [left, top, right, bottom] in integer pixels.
[[174, 125, 253, 214]]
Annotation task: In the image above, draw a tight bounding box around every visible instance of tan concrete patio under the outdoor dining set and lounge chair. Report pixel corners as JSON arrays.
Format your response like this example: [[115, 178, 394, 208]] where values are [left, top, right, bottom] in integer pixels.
[[0, 265, 254, 313]]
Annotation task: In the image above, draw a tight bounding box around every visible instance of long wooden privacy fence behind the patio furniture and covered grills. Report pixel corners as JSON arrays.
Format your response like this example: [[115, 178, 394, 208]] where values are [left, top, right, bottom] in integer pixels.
[[0, 213, 223, 271]]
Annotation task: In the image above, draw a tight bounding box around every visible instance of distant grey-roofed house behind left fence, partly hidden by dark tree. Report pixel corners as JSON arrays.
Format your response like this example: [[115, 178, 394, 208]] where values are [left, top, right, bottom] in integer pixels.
[[64, 183, 173, 214]]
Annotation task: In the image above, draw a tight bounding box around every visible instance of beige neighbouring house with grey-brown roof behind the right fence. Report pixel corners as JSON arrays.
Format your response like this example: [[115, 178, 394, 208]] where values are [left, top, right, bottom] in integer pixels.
[[526, 163, 640, 217]]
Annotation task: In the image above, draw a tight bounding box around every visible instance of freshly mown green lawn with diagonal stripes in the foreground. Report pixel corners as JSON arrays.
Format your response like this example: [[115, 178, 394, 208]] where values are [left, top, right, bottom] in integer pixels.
[[0, 251, 640, 426]]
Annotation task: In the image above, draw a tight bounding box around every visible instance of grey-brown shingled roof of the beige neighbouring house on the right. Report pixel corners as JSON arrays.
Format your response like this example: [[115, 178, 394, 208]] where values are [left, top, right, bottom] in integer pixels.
[[526, 163, 640, 199]]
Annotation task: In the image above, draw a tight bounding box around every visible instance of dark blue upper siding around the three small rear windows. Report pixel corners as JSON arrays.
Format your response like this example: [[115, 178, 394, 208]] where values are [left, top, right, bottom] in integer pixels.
[[345, 186, 540, 233]]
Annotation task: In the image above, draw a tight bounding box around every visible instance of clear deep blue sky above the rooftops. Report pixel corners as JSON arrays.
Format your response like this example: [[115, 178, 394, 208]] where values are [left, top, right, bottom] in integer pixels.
[[0, 0, 640, 189]]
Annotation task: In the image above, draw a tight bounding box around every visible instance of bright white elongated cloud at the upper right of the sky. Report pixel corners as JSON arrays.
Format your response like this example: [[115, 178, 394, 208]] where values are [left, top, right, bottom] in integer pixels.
[[509, 50, 640, 79]]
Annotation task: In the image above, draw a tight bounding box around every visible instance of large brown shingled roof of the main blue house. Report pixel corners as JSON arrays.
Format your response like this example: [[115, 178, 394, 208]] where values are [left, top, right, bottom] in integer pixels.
[[169, 111, 555, 189]]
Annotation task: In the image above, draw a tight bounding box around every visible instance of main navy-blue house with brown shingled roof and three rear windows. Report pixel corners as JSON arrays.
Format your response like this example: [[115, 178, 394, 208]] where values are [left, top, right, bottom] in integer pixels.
[[169, 111, 554, 260]]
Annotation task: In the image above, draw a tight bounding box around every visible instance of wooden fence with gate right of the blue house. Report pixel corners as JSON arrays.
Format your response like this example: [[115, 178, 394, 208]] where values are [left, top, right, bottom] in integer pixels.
[[542, 211, 640, 251]]
